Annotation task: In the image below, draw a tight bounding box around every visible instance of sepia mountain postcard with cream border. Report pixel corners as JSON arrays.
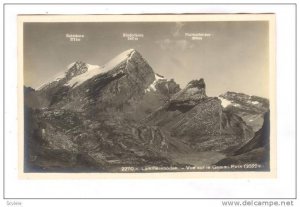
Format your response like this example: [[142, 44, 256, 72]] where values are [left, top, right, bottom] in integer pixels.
[[18, 14, 276, 178]]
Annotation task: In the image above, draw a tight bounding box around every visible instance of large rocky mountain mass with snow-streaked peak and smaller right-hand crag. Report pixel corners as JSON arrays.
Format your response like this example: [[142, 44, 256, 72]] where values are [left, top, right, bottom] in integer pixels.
[[24, 50, 268, 172]]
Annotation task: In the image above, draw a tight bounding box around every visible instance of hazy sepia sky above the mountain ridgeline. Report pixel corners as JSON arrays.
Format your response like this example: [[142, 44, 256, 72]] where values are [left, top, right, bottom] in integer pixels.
[[24, 21, 269, 97]]
